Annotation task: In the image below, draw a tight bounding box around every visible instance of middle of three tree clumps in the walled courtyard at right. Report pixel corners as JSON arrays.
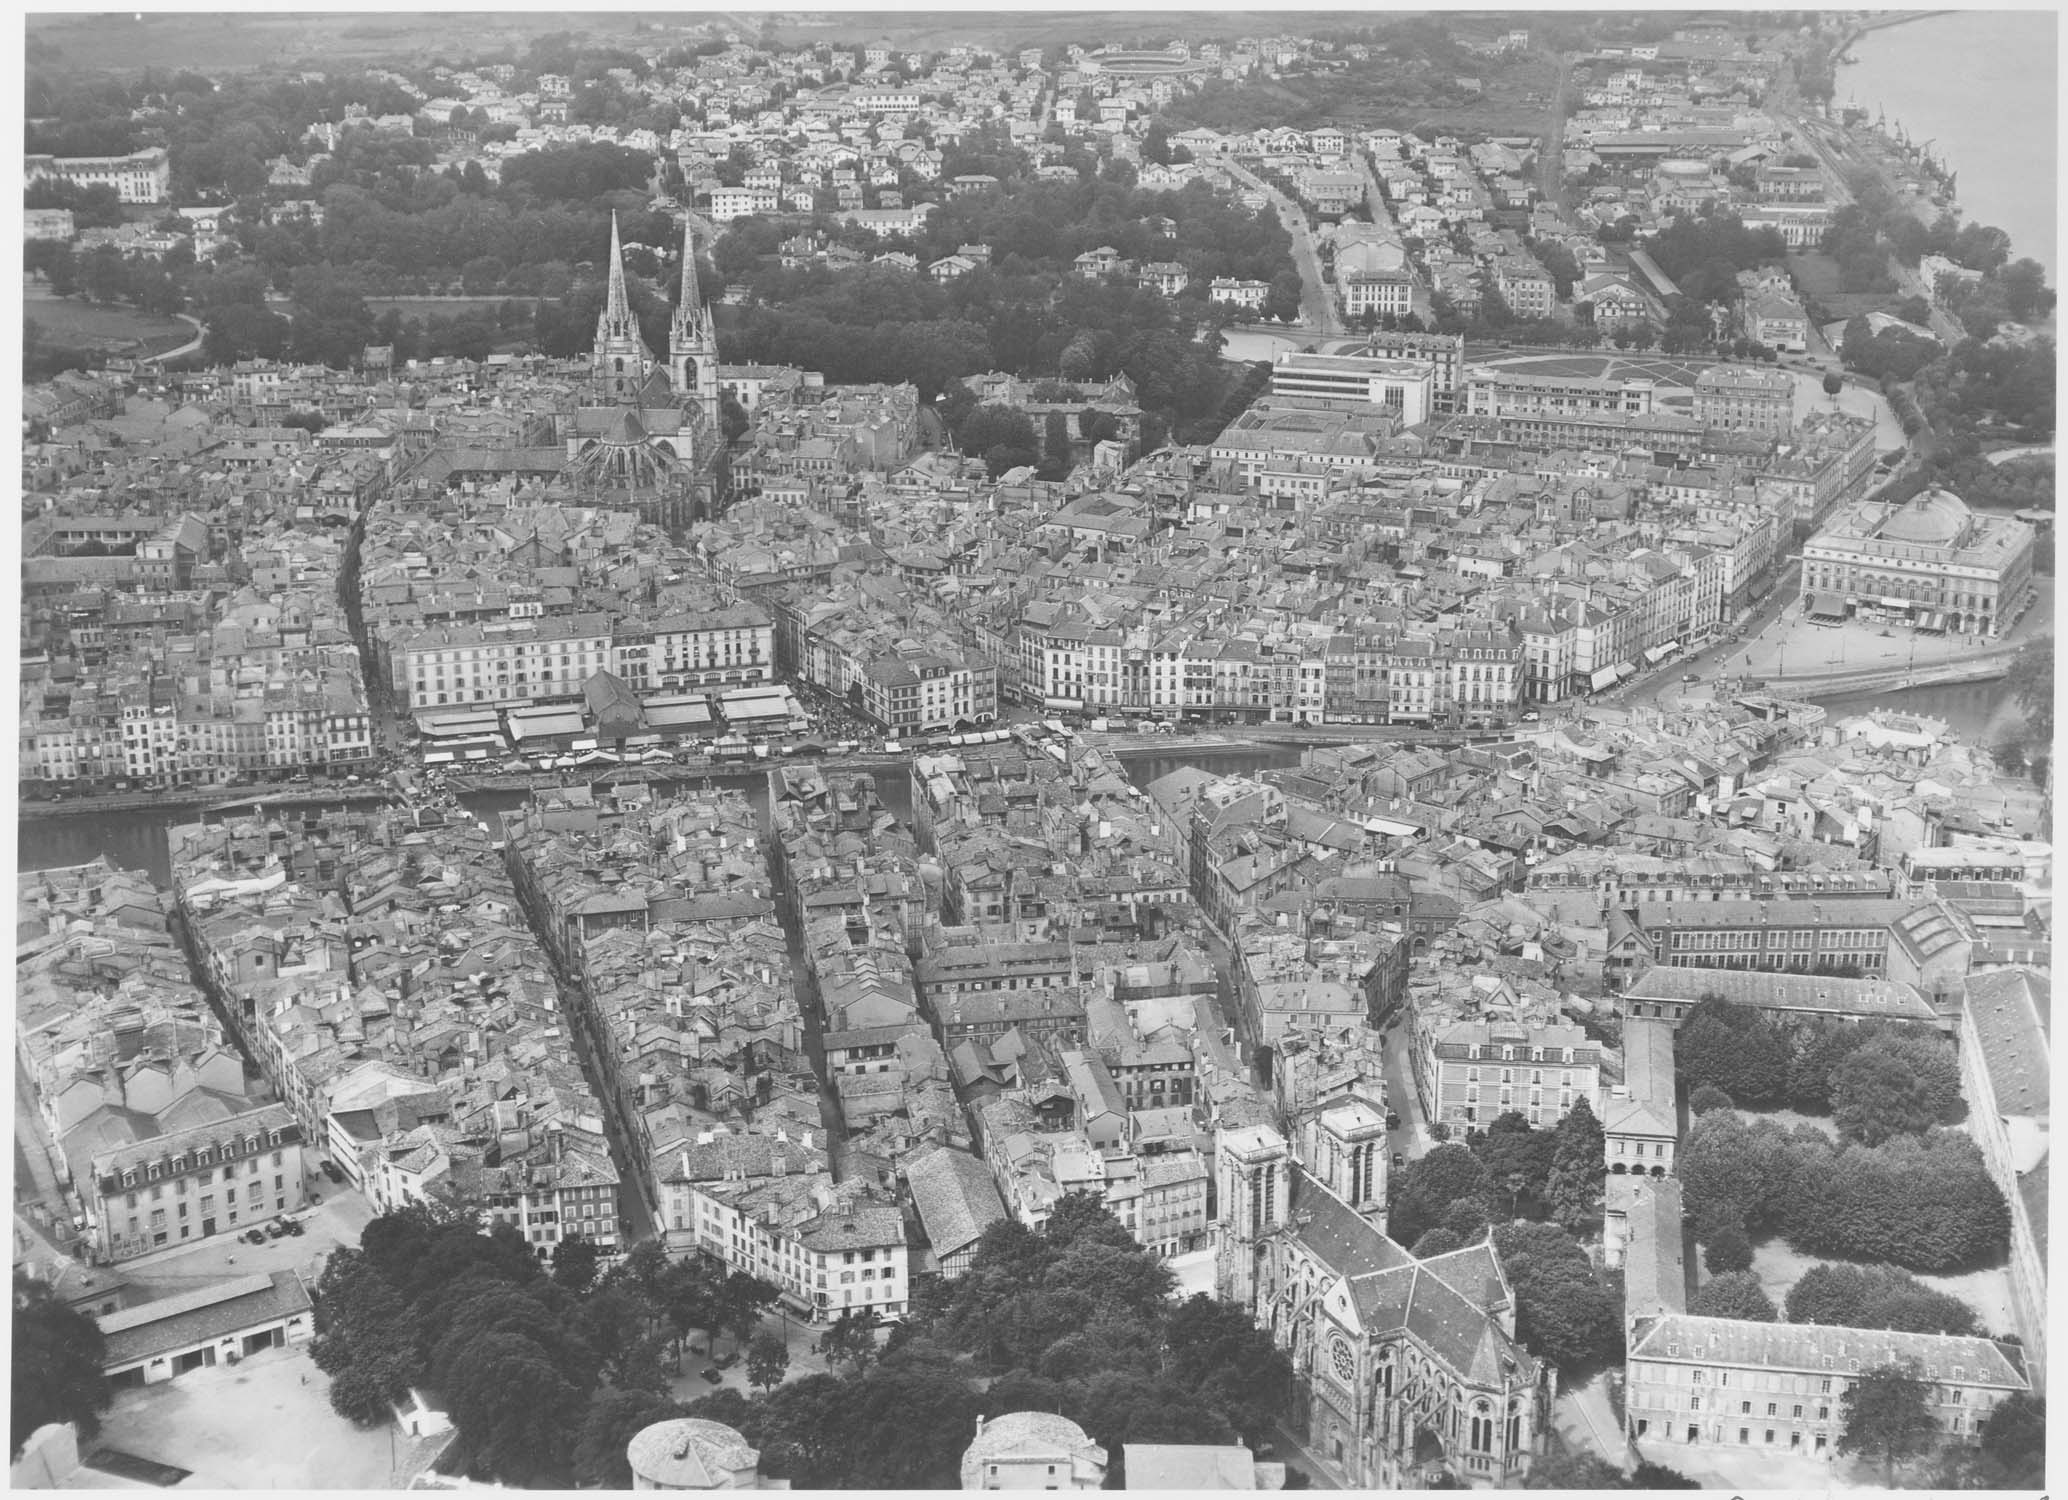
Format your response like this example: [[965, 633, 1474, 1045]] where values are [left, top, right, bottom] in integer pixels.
[[1677, 1109, 2010, 1274]]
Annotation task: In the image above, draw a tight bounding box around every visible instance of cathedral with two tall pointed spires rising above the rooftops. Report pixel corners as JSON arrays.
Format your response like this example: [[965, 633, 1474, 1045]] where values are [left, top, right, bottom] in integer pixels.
[[562, 213, 726, 528]]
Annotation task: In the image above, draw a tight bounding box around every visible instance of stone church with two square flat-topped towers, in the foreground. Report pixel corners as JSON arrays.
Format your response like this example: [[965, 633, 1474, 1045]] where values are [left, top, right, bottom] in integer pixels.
[[1214, 1101, 1553, 1490]]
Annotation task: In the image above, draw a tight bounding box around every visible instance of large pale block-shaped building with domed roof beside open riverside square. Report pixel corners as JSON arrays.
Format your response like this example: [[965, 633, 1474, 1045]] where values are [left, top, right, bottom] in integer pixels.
[[1803, 488, 2033, 635]]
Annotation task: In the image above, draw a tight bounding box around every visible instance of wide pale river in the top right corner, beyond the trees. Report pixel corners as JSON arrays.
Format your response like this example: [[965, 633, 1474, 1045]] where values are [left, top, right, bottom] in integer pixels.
[[1834, 10, 2060, 281]]
